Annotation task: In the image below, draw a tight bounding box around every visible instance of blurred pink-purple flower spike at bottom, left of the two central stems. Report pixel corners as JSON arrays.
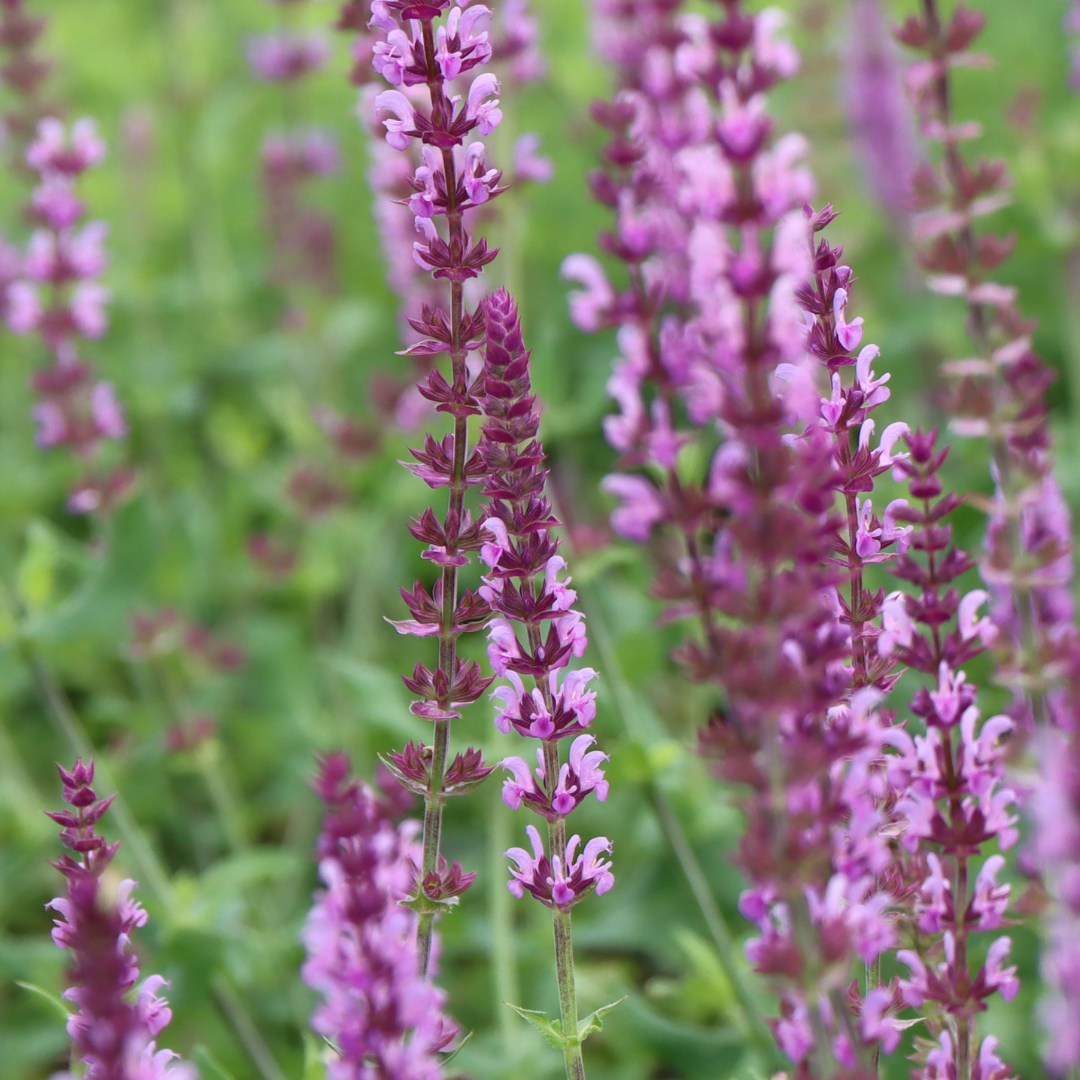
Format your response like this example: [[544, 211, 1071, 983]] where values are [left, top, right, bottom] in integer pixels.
[[300, 754, 458, 1080]]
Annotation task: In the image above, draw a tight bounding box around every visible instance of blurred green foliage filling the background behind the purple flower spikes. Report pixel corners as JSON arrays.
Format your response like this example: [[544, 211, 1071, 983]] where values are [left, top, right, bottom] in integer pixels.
[[0, 0, 1080, 1080]]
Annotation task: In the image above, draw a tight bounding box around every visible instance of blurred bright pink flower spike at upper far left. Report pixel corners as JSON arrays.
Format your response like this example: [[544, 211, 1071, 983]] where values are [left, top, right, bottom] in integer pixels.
[[6, 117, 132, 514]]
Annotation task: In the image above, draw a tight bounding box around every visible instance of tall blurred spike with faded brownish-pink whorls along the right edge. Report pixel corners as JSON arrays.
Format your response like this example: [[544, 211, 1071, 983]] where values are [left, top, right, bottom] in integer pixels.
[[897, 0, 1080, 1072]]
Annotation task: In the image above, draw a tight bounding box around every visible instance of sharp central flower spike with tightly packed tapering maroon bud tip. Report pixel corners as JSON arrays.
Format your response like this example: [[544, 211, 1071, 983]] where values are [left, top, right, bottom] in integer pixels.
[[481, 288, 615, 1080]]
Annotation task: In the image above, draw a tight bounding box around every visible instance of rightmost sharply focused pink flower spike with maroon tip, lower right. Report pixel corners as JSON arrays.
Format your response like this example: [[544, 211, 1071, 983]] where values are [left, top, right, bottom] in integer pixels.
[[878, 432, 1018, 1080]]
